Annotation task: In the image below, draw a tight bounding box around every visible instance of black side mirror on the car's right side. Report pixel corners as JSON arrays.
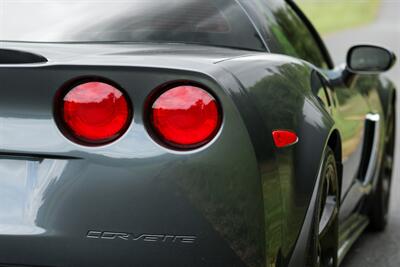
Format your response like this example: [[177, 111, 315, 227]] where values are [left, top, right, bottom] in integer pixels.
[[347, 45, 396, 74]]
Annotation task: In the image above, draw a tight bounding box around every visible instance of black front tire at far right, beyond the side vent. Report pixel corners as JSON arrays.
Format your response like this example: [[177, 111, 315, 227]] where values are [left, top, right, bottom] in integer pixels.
[[369, 109, 396, 232]]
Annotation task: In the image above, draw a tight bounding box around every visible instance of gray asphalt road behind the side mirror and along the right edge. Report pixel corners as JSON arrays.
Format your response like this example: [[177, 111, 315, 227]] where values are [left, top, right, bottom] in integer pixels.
[[325, 0, 400, 267]]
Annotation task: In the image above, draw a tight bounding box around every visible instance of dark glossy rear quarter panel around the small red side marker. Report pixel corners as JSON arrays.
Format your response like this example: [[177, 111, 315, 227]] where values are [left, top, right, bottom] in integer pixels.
[[221, 55, 334, 266]]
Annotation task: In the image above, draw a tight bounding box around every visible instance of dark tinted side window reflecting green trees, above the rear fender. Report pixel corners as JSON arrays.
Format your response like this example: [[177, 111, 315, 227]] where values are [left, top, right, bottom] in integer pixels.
[[241, 0, 328, 68]]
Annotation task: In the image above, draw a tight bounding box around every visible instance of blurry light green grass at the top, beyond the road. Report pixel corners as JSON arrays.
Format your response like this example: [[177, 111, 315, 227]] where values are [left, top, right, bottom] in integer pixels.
[[297, 0, 381, 34]]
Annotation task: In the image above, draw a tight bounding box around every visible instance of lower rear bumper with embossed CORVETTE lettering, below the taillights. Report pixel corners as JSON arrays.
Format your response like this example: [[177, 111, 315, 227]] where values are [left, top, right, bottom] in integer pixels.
[[0, 99, 265, 267]]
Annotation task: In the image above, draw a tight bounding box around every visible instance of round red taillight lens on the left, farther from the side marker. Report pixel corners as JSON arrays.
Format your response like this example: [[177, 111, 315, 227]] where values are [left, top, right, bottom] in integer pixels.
[[61, 82, 131, 145]]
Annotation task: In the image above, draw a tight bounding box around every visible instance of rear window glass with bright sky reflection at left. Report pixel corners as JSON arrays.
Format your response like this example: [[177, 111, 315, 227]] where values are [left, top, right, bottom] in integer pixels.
[[0, 0, 265, 51]]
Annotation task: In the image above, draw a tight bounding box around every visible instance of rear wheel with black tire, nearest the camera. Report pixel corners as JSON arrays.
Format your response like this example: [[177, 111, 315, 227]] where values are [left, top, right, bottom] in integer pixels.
[[314, 147, 339, 267]]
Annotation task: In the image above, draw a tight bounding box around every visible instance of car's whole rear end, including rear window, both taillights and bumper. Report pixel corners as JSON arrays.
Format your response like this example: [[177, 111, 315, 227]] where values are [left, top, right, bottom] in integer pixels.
[[0, 0, 272, 267]]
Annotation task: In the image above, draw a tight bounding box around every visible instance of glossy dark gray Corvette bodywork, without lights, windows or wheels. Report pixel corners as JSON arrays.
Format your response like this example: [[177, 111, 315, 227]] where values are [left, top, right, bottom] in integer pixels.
[[0, 2, 393, 267]]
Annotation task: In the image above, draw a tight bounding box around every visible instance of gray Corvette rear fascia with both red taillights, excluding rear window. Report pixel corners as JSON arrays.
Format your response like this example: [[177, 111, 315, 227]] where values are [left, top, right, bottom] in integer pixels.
[[0, 43, 264, 267]]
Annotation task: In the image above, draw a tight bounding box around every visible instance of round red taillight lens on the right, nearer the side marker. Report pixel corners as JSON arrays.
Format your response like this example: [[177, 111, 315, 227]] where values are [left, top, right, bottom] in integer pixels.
[[151, 85, 221, 149]]
